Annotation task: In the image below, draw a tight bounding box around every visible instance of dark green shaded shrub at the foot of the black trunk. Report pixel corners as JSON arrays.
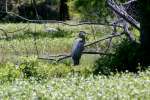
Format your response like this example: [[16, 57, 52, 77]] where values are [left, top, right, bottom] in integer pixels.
[[94, 39, 142, 75]]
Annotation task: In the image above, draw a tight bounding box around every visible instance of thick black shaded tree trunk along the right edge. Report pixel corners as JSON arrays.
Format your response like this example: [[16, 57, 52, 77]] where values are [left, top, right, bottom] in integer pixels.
[[138, 0, 150, 66]]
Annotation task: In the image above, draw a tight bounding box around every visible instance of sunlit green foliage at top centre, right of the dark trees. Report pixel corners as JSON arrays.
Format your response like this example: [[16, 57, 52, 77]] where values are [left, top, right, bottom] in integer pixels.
[[69, 0, 110, 21]]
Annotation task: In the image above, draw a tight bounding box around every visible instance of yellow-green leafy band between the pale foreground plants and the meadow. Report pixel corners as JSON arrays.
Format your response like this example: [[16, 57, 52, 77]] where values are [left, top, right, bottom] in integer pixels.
[[0, 57, 93, 84]]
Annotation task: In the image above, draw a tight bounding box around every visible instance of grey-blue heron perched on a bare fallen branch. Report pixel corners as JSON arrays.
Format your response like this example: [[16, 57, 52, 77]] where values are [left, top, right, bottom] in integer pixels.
[[71, 31, 86, 66]]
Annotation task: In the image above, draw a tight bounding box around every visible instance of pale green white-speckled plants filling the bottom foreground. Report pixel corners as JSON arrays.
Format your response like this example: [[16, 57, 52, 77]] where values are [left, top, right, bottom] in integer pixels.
[[0, 70, 150, 100]]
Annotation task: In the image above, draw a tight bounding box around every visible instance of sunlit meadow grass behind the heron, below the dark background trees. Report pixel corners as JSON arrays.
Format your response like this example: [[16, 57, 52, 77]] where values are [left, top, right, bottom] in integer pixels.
[[0, 23, 110, 62]]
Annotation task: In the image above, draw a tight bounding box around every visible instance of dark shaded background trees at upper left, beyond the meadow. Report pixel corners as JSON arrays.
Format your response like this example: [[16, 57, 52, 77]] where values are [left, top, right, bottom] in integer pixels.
[[0, 0, 69, 22]]
